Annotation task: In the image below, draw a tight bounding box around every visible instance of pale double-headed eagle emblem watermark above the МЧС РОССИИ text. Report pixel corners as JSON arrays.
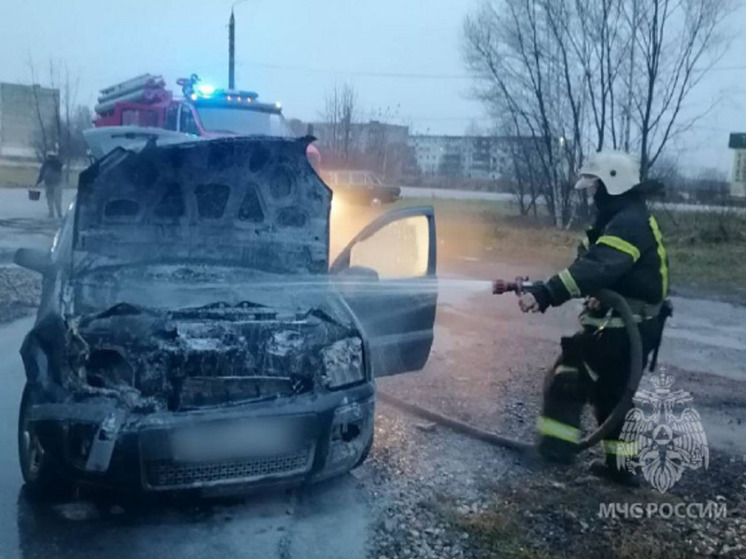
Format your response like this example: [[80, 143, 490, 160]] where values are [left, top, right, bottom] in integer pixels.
[[617, 373, 710, 493]]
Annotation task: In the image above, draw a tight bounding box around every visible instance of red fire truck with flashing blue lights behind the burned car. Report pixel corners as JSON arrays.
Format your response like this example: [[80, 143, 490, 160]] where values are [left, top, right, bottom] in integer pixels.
[[93, 74, 321, 170]]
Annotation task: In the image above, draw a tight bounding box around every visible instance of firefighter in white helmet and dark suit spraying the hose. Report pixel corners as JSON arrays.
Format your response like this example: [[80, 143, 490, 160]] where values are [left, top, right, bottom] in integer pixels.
[[519, 151, 668, 484]]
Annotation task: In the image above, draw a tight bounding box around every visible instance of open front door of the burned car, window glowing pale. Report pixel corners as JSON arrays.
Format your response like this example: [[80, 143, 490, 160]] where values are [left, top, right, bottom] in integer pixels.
[[330, 207, 438, 377]]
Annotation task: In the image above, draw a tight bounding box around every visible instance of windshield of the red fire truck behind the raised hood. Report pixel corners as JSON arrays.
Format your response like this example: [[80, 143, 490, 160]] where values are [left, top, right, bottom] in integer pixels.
[[192, 106, 293, 137]]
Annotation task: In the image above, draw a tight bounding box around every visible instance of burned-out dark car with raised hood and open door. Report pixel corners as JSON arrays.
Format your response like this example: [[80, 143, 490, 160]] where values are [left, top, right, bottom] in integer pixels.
[[16, 137, 437, 494]]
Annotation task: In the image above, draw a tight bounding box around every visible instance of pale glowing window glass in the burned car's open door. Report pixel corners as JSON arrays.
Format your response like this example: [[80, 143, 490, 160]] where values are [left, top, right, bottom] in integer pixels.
[[350, 216, 430, 279]]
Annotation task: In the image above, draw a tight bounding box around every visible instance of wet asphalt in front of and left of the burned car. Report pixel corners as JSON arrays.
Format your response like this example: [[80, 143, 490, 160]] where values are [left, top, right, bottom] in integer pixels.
[[0, 319, 372, 559]]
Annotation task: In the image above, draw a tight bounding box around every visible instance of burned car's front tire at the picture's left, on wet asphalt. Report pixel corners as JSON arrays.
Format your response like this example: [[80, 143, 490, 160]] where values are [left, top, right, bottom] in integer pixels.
[[18, 383, 73, 499]]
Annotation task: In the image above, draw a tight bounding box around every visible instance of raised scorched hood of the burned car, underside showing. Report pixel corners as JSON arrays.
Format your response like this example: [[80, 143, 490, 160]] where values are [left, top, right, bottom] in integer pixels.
[[73, 137, 331, 273]]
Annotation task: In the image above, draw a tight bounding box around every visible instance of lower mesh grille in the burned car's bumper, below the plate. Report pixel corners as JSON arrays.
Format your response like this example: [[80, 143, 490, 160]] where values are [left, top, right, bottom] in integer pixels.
[[145, 448, 313, 489]]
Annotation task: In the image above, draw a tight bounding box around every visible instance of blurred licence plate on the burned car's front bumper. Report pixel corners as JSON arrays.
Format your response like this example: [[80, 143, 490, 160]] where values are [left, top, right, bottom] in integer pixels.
[[171, 420, 298, 462]]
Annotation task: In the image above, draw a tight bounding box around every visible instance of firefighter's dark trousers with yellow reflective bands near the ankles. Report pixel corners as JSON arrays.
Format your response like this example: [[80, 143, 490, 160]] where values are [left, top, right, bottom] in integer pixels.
[[538, 318, 660, 468]]
